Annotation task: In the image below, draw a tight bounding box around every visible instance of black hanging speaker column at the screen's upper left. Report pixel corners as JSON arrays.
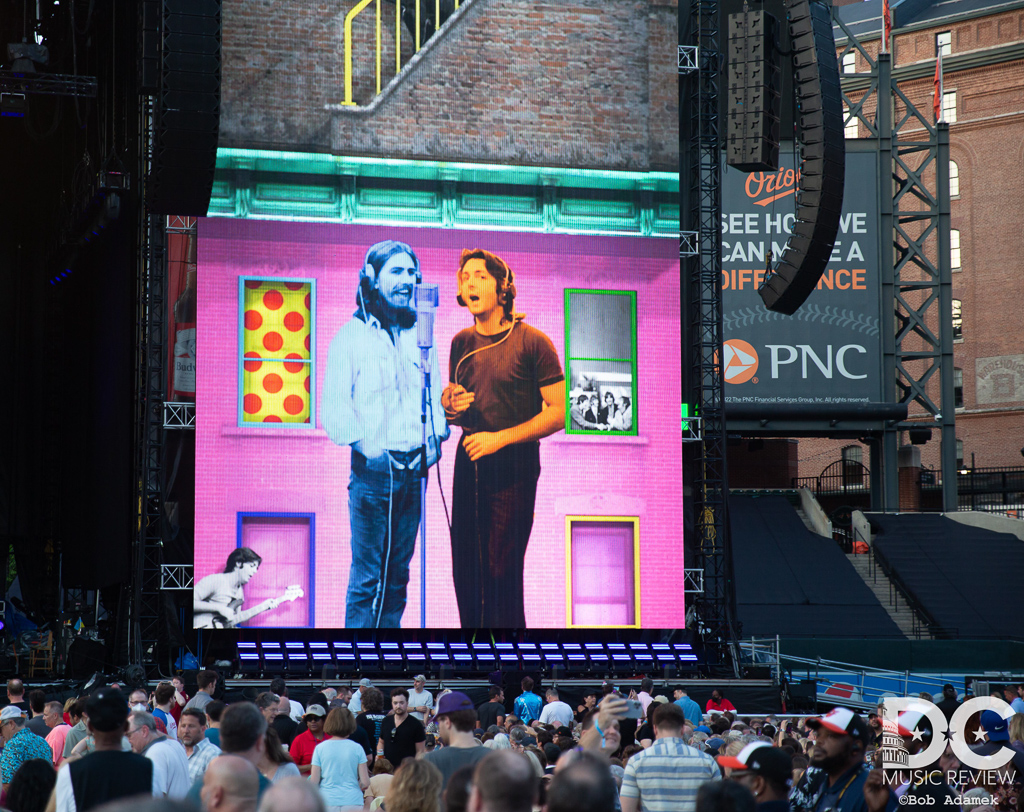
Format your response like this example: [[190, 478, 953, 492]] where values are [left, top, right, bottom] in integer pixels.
[[146, 0, 221, 217]]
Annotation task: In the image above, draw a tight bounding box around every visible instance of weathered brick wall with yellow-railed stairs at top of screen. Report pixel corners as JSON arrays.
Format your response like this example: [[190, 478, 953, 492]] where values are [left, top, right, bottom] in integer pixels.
[[220, 0, 679, 172]]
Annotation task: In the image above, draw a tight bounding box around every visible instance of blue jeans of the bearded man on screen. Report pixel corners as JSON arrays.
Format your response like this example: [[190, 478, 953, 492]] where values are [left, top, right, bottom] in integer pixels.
[[345, 450, 420, 629]]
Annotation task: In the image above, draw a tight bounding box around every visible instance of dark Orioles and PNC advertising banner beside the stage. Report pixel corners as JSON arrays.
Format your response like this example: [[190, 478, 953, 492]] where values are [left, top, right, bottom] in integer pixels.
[[722, 145, 882, 408]]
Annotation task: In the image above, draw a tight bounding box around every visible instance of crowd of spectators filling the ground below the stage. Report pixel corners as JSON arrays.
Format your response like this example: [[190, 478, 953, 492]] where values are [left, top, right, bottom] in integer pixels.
[[0, 671, 1024, 812]]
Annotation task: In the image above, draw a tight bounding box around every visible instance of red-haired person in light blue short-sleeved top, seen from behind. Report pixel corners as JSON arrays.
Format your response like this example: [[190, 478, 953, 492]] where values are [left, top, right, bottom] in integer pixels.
[[309, 708, 370, 812]]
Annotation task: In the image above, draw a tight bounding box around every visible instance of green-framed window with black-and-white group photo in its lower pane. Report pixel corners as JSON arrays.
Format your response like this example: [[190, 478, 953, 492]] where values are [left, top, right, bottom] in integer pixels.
[[564, 288, 639, 436]]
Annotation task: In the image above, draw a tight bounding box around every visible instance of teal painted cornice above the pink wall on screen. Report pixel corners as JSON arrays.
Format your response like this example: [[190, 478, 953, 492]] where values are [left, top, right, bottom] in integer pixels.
[[209, 148, 679, 240]]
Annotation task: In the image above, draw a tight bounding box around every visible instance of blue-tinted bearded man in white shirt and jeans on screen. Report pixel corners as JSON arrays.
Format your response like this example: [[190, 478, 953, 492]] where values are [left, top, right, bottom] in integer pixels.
[[321, 240, 449, 629]]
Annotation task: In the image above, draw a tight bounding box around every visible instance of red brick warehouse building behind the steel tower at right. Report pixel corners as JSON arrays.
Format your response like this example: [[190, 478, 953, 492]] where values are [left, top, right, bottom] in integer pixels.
[[749, 3, 1024, 497]]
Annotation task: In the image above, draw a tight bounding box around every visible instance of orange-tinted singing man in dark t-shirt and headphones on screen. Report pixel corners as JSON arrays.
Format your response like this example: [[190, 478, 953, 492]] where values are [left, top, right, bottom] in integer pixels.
[[441, 249, 565, 629]]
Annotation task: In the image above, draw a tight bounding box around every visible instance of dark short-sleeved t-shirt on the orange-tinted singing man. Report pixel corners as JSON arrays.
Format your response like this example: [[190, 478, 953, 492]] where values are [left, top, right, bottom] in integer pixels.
[[449, 322, 565, 433]]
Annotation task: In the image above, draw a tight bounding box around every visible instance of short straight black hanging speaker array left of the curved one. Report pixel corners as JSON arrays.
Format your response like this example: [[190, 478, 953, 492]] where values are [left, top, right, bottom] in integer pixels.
[[726, 11, 781, 172]]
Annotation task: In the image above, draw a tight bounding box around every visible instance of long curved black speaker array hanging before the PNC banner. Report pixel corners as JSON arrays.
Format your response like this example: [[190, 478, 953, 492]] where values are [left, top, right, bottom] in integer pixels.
[[758, 0, 846, 315]]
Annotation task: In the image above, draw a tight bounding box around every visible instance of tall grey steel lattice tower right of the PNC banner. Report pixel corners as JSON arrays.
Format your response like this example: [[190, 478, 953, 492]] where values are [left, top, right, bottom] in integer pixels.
[[833, 8, 956, 511]]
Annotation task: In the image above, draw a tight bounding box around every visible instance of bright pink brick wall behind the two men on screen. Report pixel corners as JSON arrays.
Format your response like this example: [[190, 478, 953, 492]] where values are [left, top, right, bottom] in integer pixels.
[[195, 219, 684, 628]]
